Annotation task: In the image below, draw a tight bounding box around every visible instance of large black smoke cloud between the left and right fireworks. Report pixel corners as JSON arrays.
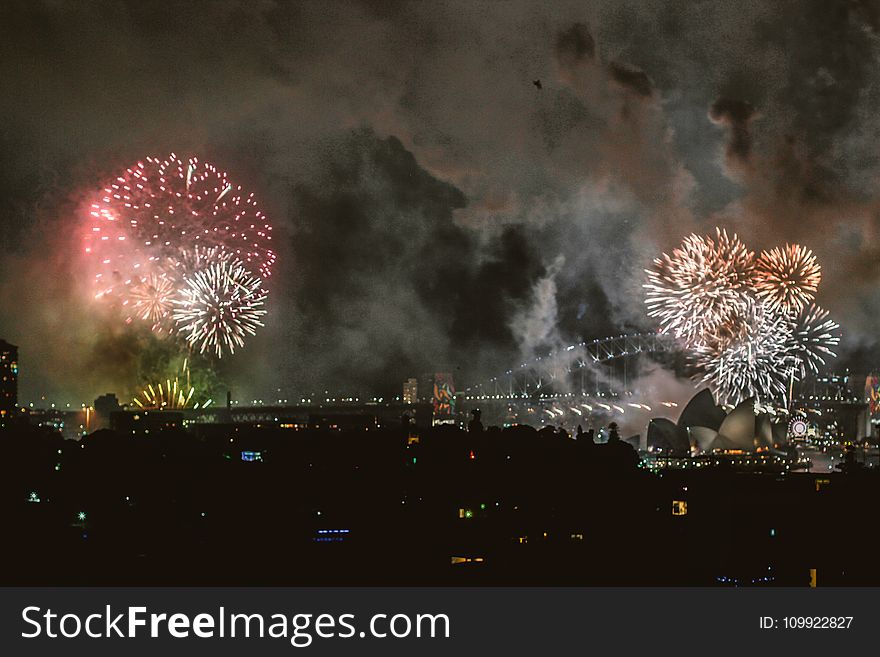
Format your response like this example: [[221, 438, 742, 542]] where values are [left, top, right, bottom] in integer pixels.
[[285, 129, 535, 390]]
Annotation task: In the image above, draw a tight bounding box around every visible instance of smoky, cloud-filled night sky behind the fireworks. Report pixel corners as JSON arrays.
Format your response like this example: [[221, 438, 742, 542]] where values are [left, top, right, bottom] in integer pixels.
[[0, 0, 880, 402]]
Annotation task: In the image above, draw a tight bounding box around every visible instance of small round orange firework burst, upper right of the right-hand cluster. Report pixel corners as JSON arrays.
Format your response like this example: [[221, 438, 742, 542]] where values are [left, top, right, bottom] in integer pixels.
[[754, 244, 822, 313]]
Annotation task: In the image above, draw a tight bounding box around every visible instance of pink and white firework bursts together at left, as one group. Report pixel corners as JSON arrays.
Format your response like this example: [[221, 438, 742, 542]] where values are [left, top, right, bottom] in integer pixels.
[[84, 153, 275, 358]]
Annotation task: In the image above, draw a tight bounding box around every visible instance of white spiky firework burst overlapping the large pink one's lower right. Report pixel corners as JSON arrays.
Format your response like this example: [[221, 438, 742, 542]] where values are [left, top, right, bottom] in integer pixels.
[[173, 258, 266, 358]]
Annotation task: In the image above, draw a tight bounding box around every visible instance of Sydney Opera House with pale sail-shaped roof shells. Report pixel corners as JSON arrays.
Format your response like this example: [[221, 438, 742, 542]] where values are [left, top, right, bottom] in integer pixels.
[[646, 389, 787, 457]]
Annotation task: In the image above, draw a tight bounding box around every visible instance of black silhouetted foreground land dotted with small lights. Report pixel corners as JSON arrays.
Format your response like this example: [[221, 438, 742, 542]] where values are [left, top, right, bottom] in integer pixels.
[[0, 417, 880, 586]]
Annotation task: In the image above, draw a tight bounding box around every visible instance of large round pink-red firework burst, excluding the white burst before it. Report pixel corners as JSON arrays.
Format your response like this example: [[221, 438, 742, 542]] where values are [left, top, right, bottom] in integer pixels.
[[82, 153, 276, 346]]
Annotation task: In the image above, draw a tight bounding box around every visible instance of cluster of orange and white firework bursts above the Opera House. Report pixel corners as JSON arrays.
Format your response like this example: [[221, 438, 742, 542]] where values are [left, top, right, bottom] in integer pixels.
[[644, 229, 840, 404]]
